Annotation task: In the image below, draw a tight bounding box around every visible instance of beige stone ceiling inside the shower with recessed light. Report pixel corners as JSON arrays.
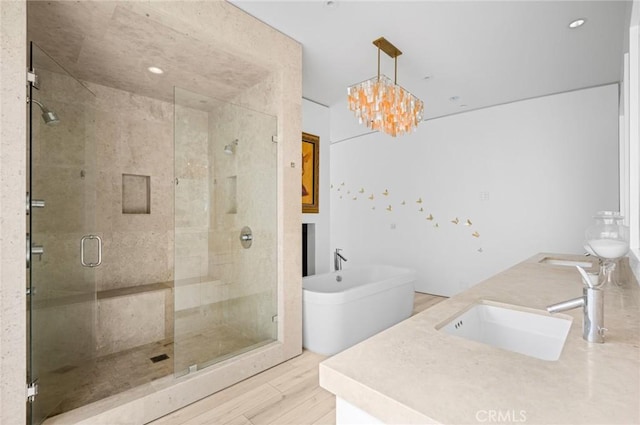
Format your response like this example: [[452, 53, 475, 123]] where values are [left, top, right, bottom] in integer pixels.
[[27, 0, 271, 110]]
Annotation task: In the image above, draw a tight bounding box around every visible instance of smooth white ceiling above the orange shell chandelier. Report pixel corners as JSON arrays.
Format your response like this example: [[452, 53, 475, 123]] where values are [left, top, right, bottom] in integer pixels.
[[231, 0, 631, 119]]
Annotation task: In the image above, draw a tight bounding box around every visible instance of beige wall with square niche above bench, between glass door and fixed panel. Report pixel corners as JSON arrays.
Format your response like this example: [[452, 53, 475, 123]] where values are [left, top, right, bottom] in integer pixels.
[[88, 80, 174, 291]]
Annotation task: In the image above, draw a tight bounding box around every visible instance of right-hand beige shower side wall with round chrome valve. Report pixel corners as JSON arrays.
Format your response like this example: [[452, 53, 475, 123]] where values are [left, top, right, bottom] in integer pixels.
[[209, 86, 277, 340]]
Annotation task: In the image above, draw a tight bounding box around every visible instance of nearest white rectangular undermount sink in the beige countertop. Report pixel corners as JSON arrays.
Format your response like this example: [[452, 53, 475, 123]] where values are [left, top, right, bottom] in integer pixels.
[[436, 300, 573, 361]]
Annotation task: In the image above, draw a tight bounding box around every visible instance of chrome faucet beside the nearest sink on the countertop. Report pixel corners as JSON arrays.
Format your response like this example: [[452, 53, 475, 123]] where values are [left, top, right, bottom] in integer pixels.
[[547, 266, 607, 344]]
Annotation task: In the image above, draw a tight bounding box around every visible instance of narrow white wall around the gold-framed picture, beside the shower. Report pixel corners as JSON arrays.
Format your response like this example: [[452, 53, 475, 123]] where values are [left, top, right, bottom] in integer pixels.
[[300, 99, 331, 274]]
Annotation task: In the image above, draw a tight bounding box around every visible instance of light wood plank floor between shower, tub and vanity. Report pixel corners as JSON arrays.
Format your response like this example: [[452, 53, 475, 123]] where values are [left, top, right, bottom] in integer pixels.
[[151, 292, 446, 425]]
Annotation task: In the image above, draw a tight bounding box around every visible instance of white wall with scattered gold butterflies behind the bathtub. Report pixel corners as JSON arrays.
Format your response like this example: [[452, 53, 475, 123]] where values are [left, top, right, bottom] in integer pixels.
[[330, 84, 619, 295]]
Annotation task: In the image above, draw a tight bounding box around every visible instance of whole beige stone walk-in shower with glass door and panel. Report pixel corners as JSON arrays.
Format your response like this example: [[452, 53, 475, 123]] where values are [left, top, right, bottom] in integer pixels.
[[27, 4, 278, 424]]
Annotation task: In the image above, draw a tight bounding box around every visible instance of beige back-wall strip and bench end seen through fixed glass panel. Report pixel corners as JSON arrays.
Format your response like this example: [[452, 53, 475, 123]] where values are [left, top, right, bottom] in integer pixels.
[[175, 97, 226, 342]]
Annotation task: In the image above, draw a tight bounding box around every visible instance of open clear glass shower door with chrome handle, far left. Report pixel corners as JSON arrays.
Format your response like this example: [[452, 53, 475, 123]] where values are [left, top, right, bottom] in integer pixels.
[[27, 43, 101, 424]]
